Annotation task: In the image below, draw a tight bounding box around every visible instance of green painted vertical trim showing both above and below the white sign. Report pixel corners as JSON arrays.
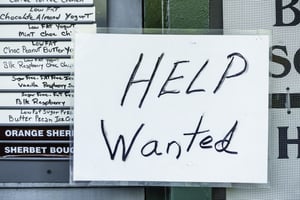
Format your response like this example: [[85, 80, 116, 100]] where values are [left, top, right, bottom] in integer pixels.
[[144, 0, 212, 200]]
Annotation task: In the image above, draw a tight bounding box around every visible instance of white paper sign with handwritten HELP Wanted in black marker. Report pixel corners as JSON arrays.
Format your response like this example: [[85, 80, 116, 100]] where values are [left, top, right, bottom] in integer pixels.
[[73, 34, 269, 183]]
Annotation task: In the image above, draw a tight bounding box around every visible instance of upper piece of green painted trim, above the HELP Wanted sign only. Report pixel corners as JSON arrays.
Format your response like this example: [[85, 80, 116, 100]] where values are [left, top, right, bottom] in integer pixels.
[[144, 0, 209, 29]]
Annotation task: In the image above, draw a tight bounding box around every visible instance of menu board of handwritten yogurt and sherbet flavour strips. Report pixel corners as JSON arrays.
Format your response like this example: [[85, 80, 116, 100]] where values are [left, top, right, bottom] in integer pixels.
[[0, 0, 96, 160]]
